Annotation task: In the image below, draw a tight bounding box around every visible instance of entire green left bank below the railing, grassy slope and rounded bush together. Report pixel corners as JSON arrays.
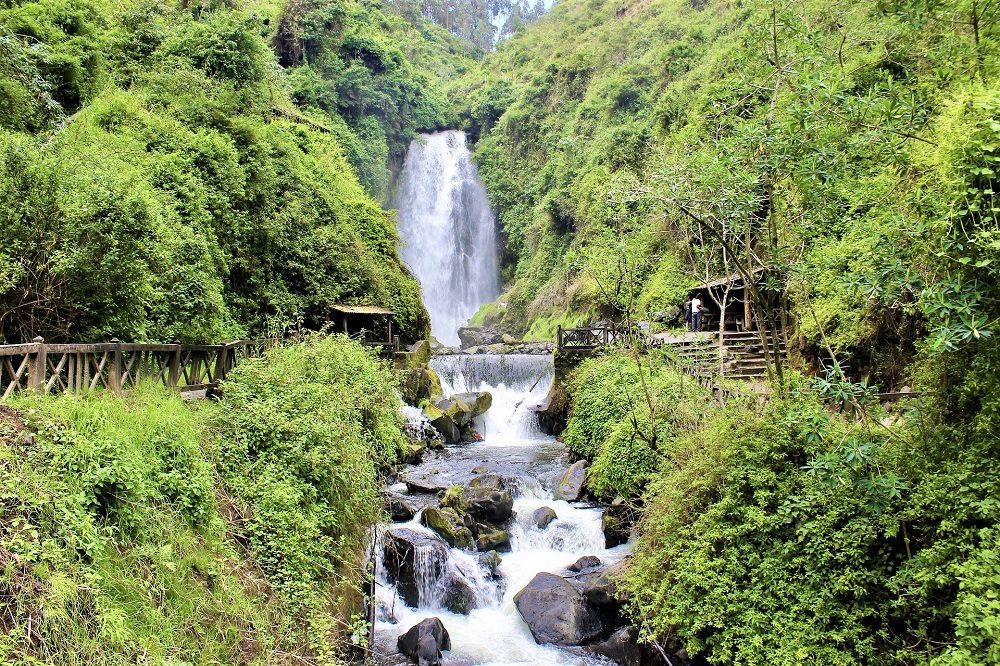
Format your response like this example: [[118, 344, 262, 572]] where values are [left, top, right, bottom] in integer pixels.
[[0, 338, 401, 664]]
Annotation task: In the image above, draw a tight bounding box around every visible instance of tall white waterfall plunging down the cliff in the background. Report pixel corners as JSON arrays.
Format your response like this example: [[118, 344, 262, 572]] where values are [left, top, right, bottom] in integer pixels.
[[396, 130, 500, 345]]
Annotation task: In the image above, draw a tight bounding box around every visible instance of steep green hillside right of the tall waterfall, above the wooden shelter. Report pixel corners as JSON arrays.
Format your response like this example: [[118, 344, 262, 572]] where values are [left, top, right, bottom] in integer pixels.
[[452, 0, 997, 368]]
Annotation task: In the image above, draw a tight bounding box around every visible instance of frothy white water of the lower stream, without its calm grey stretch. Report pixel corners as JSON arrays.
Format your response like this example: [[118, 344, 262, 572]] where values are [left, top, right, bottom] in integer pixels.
[[376, 355, 626, 666]]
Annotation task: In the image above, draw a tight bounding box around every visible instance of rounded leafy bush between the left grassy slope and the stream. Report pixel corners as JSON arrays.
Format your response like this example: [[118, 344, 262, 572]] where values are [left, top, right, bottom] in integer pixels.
[[209, 336, 403, 651]]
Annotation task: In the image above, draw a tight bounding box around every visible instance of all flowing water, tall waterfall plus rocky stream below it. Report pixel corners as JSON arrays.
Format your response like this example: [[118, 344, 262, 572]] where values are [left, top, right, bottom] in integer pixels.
[[374, 131, 629, 666]]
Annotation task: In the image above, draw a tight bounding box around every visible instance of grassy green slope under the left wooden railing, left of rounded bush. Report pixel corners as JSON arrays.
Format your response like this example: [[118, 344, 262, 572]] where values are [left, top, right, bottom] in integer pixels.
[[0, 387, 299, 666]]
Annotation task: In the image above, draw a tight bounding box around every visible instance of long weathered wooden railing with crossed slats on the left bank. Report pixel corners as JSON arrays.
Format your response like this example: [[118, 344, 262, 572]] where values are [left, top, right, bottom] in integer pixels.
[[0, 338, 280, 399]]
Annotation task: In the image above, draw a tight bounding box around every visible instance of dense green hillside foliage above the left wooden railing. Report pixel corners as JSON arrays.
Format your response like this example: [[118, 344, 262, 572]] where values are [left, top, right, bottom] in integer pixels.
[[0, 0, 438, 342]]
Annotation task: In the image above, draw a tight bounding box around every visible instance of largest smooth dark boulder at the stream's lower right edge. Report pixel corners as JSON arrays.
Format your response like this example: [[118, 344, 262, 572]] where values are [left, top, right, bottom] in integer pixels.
[[514, 572, 604, 645]]
